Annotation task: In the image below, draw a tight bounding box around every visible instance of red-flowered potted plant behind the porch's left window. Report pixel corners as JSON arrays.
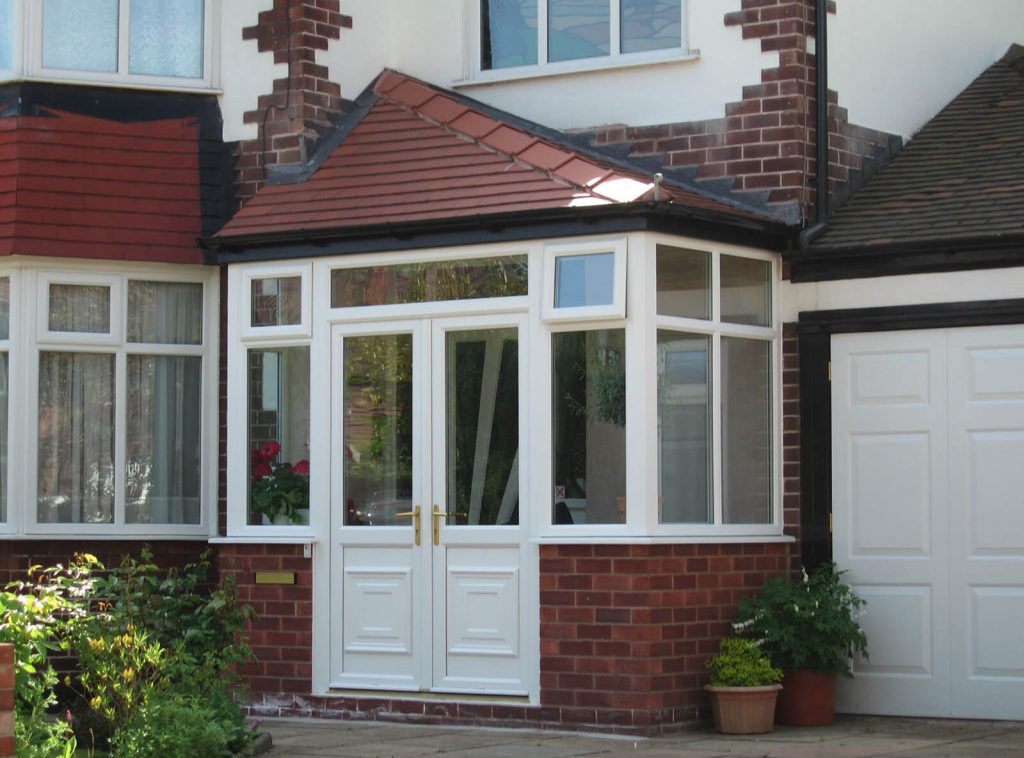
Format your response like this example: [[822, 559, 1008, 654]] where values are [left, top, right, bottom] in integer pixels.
[[249, 441, 309, 524]]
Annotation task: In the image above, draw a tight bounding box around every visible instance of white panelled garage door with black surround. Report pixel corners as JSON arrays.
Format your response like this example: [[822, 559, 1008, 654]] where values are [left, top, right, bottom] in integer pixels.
[[831, 326, 1024, 719]]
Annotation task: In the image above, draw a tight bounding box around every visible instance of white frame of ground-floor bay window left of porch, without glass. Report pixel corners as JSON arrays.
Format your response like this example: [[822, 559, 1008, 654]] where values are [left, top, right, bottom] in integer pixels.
[[19, 261, 219, 539]]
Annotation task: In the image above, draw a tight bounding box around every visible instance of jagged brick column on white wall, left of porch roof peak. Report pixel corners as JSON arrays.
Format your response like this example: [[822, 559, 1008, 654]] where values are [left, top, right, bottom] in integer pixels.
[[237, 0, 352, 202]]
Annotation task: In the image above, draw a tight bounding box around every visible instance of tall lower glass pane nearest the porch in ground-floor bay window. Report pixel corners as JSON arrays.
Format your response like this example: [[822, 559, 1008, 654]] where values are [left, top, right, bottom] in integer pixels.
[[125, 355, 203, 523]]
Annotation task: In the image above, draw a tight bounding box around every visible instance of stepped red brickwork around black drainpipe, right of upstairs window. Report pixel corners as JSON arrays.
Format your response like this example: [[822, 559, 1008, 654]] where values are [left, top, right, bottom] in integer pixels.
[[594, 0, 891, 217]]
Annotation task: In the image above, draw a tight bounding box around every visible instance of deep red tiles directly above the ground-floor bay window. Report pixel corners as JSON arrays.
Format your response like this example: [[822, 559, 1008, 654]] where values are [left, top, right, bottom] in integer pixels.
[[0, 112, 203, 263]]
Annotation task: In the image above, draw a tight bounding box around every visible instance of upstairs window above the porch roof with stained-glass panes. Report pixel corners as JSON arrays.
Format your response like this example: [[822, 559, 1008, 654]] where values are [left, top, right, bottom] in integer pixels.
[[480, 0, 684, 71]]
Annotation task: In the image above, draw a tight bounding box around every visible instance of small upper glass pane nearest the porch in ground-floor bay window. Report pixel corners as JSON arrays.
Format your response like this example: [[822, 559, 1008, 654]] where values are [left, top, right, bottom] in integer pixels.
[[128, 282, 203, 345]]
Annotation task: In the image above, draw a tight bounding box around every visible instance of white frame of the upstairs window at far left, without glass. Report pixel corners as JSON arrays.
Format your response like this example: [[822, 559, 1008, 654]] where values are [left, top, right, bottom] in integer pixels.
[[21, 0, 221, 91]]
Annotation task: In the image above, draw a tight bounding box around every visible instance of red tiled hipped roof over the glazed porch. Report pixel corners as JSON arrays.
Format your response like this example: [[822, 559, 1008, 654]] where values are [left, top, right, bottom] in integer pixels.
[[218, 71, 767, 238]]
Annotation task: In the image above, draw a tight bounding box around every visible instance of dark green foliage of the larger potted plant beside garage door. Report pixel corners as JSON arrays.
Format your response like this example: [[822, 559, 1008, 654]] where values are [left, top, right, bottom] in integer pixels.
[[733, 563, 867, 677]]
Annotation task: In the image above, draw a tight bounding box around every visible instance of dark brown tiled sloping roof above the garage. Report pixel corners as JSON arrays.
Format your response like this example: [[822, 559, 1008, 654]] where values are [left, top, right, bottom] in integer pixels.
[[812, 45, 1024, 250]]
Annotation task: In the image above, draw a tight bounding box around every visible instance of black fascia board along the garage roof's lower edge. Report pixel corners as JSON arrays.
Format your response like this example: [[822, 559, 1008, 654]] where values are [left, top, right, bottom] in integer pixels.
[[782, 234, 1024, 283]]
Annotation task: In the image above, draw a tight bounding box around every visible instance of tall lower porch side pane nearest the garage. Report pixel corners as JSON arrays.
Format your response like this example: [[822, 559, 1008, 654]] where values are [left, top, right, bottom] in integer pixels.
[[722, 337, 771, 523]]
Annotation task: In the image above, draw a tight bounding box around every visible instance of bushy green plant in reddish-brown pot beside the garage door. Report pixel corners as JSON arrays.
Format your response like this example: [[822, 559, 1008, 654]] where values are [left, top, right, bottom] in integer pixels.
[[734, 562, 867, 726]]
